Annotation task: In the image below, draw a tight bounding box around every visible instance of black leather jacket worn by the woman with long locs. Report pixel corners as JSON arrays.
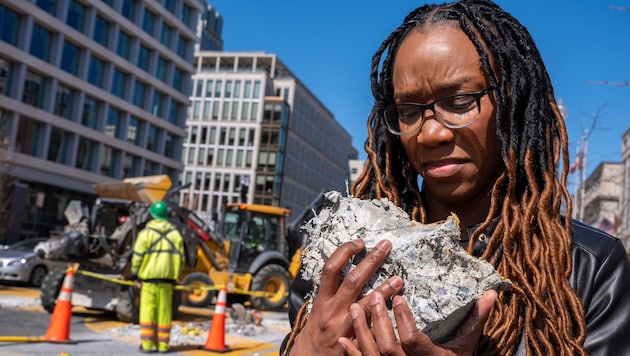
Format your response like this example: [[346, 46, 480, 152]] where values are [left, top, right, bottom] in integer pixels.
[[280, 221, 630, 356]]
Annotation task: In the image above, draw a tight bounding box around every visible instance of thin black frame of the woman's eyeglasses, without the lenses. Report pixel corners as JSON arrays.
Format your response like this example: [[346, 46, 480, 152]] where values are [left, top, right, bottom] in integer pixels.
[[381, 86, 496, 136]]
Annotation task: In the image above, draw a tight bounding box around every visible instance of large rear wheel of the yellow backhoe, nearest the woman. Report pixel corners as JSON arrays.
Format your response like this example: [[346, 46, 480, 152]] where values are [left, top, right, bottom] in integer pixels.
[[250, 264, 291, 311]]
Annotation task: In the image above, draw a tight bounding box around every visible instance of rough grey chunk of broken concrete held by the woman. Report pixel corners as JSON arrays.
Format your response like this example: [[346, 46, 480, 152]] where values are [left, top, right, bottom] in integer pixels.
[[302, 191, 511, 342]]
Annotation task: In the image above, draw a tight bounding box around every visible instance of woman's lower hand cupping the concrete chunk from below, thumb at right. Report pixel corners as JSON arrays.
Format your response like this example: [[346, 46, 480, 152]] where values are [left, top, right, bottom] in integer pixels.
[[339, 290, 497, 356]]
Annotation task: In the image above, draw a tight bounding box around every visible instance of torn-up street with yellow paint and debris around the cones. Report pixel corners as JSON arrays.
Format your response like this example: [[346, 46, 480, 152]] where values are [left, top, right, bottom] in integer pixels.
[[0, 284, 289, 356]]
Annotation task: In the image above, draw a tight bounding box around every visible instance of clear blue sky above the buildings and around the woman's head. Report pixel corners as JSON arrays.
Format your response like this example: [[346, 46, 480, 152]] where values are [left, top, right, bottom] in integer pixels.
[[209, 0, 630, 186]]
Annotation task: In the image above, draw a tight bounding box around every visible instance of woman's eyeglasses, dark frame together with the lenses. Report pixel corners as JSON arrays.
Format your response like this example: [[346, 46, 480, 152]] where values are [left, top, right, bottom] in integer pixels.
[[382, 87, 495, 136]]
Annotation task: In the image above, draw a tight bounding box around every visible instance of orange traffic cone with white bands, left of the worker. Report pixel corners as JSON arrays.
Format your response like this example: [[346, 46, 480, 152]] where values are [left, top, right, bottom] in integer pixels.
[[45, 264, 79, 343]]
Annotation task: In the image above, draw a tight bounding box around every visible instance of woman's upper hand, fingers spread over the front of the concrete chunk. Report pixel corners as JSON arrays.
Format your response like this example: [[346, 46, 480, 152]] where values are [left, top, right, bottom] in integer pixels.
[[291, 240, 403, 356]]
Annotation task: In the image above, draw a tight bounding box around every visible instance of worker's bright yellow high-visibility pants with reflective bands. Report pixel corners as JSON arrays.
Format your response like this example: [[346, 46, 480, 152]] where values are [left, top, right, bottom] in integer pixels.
[[140, 282, 173, 351]]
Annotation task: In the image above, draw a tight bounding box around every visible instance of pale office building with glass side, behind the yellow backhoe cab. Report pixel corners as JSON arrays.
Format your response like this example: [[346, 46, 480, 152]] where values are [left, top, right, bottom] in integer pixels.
[[182, 51, 357, 220]]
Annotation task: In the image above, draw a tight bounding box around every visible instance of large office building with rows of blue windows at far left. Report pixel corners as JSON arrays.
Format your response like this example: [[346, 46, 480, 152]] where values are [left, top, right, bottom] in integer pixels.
[[0, 0, 207, 242]]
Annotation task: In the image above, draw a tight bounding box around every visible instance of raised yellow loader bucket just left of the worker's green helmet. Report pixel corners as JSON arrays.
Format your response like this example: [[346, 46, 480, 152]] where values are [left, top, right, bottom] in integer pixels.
[[93, 174, 172, 204]]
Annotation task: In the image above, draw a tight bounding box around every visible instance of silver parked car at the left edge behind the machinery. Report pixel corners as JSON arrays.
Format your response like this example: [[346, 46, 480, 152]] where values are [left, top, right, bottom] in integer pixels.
[[0, 238, 65, 287]]
